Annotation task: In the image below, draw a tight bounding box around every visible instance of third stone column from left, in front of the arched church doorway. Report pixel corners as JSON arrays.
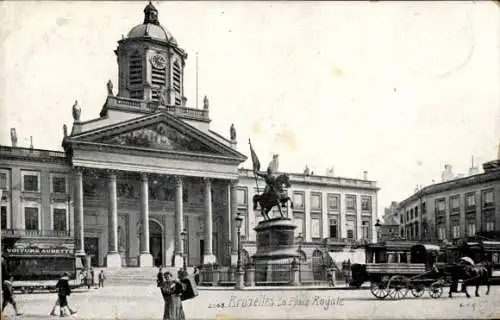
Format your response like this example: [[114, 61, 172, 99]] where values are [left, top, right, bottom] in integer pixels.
[[139, 173, 153, 267]]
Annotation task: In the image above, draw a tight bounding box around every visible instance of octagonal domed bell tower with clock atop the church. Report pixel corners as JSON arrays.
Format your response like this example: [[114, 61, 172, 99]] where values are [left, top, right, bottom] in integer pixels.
[[115, 2, 187, 106]]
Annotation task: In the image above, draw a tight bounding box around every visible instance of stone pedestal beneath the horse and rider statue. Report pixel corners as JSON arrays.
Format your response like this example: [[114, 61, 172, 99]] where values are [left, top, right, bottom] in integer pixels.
[[253, 218, 299, 282]]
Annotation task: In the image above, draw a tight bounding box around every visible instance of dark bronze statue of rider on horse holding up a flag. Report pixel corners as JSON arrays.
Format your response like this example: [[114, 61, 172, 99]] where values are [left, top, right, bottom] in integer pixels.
[[248, 140, 293, 220]]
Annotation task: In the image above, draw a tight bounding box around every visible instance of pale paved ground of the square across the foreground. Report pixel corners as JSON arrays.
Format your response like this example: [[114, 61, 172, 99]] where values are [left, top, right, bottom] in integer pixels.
[[4, 286, 500, 320]]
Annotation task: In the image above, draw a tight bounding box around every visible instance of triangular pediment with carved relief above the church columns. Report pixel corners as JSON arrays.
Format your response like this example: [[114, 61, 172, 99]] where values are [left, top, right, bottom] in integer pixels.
[[68, 112, 246, 161]]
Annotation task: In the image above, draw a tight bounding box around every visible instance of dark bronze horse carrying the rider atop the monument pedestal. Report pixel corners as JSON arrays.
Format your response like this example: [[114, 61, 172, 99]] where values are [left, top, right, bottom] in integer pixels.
[[253, 174, 293, 220]]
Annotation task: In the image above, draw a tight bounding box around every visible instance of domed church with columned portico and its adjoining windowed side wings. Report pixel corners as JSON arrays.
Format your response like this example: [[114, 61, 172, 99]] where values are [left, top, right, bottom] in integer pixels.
[[0, 3, 378, 267]]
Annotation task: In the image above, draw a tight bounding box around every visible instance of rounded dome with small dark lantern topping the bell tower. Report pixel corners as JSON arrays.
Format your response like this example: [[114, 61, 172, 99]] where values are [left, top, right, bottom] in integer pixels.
[[127, 2, 177, 45]]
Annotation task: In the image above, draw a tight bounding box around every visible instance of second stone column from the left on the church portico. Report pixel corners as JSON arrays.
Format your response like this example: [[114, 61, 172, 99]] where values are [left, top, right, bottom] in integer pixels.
[[106, 171, 122, 268]]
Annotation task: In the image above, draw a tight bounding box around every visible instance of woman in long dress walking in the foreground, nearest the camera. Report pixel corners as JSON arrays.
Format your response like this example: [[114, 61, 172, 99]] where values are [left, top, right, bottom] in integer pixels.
[[161, 272, 185, 320]]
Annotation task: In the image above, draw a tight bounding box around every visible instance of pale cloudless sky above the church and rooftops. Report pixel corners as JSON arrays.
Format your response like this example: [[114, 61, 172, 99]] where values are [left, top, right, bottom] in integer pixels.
[[0, 1, 500, 216]]
